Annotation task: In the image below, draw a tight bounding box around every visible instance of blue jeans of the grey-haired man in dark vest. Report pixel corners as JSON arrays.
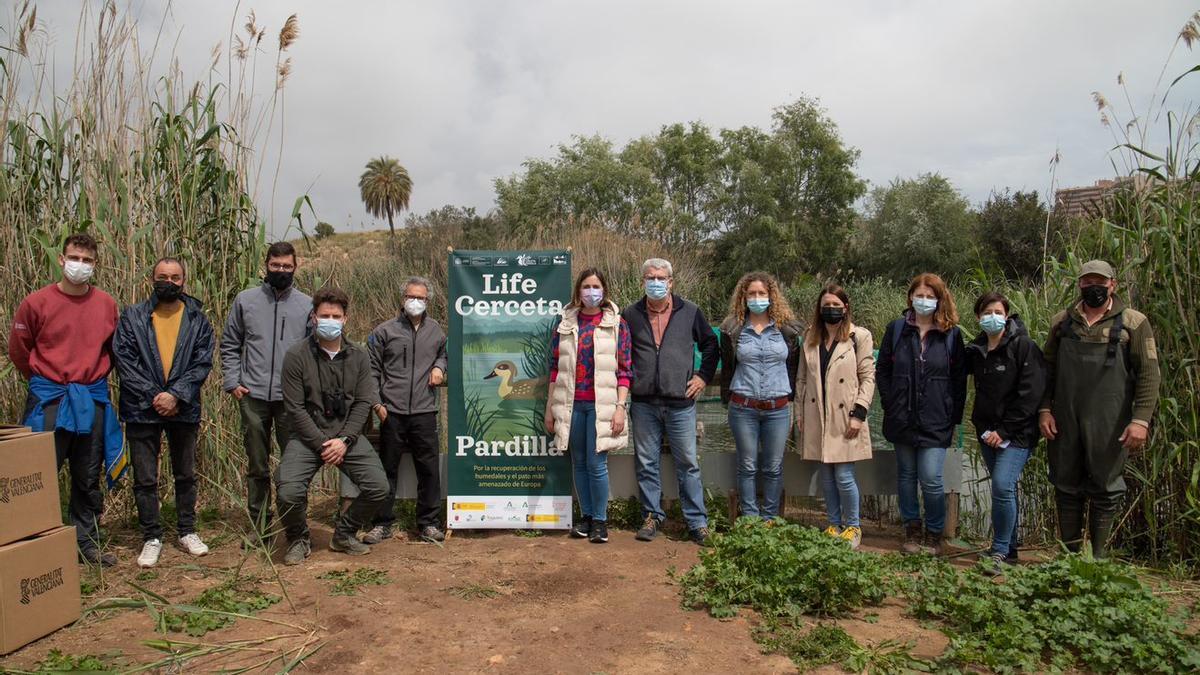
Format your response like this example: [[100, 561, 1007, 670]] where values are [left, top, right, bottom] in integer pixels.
[[629, 401, 708, 530]]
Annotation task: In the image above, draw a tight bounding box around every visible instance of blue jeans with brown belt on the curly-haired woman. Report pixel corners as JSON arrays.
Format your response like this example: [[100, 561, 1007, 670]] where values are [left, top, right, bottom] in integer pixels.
[[730, 404, 792, 518]]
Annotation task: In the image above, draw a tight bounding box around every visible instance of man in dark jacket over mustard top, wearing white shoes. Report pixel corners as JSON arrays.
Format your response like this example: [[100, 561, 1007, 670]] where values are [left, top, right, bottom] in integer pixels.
[[113, 257, 212, 567]]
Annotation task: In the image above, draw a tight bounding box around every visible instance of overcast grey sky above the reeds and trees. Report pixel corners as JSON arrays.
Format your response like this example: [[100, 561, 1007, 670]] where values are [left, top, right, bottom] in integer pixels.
[[23, 0, 1200, 232]]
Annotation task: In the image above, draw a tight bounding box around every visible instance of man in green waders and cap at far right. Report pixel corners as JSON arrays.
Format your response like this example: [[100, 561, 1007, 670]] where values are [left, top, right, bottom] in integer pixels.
[[1039, 261, 1160, 557]]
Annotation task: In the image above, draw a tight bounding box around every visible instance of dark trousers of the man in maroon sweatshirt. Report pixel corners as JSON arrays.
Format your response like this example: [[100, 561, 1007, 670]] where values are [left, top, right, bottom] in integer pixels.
[[25, 394, 104, 551]]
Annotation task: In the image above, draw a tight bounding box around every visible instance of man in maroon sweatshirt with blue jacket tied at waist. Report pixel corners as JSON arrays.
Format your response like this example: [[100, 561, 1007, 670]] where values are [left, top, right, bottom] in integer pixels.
[[8, 234, 120, 566]]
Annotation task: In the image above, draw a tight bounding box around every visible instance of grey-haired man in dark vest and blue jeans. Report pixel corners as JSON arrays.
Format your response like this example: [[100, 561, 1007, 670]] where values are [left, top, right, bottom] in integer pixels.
[[622, 258, 720, 545]]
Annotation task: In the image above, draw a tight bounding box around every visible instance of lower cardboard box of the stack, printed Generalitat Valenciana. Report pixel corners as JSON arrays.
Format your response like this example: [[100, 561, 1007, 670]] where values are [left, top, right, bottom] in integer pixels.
[[0, 527, 79, 655]]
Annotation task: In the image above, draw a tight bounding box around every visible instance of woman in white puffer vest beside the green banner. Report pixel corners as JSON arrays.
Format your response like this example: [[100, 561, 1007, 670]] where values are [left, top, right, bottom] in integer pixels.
[[545, 268, 632, 544]]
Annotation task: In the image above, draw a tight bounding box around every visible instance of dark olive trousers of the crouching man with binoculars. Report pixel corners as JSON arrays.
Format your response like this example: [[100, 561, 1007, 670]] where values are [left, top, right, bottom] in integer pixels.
[[275, 436, 388, 542]]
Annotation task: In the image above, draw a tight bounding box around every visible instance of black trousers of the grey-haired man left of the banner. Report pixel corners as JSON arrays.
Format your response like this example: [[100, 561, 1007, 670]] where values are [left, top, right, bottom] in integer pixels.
[[373, 412, 442, 528]]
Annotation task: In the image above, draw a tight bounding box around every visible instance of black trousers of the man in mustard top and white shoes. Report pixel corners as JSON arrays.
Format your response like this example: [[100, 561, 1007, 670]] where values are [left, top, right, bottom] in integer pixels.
[[125, 423, 200, 542]]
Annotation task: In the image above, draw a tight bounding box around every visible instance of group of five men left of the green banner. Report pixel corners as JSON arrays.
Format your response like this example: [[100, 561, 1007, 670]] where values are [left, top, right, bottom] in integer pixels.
[[8, 234, 446, 567]]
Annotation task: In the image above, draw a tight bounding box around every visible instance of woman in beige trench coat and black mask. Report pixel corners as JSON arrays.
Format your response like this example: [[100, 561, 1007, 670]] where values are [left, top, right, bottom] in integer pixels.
[[796, 285, 875, 549]]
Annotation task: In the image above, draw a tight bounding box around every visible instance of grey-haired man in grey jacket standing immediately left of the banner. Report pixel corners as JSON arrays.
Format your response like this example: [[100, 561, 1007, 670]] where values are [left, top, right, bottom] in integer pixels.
[[362, 276, 446, 544]]
